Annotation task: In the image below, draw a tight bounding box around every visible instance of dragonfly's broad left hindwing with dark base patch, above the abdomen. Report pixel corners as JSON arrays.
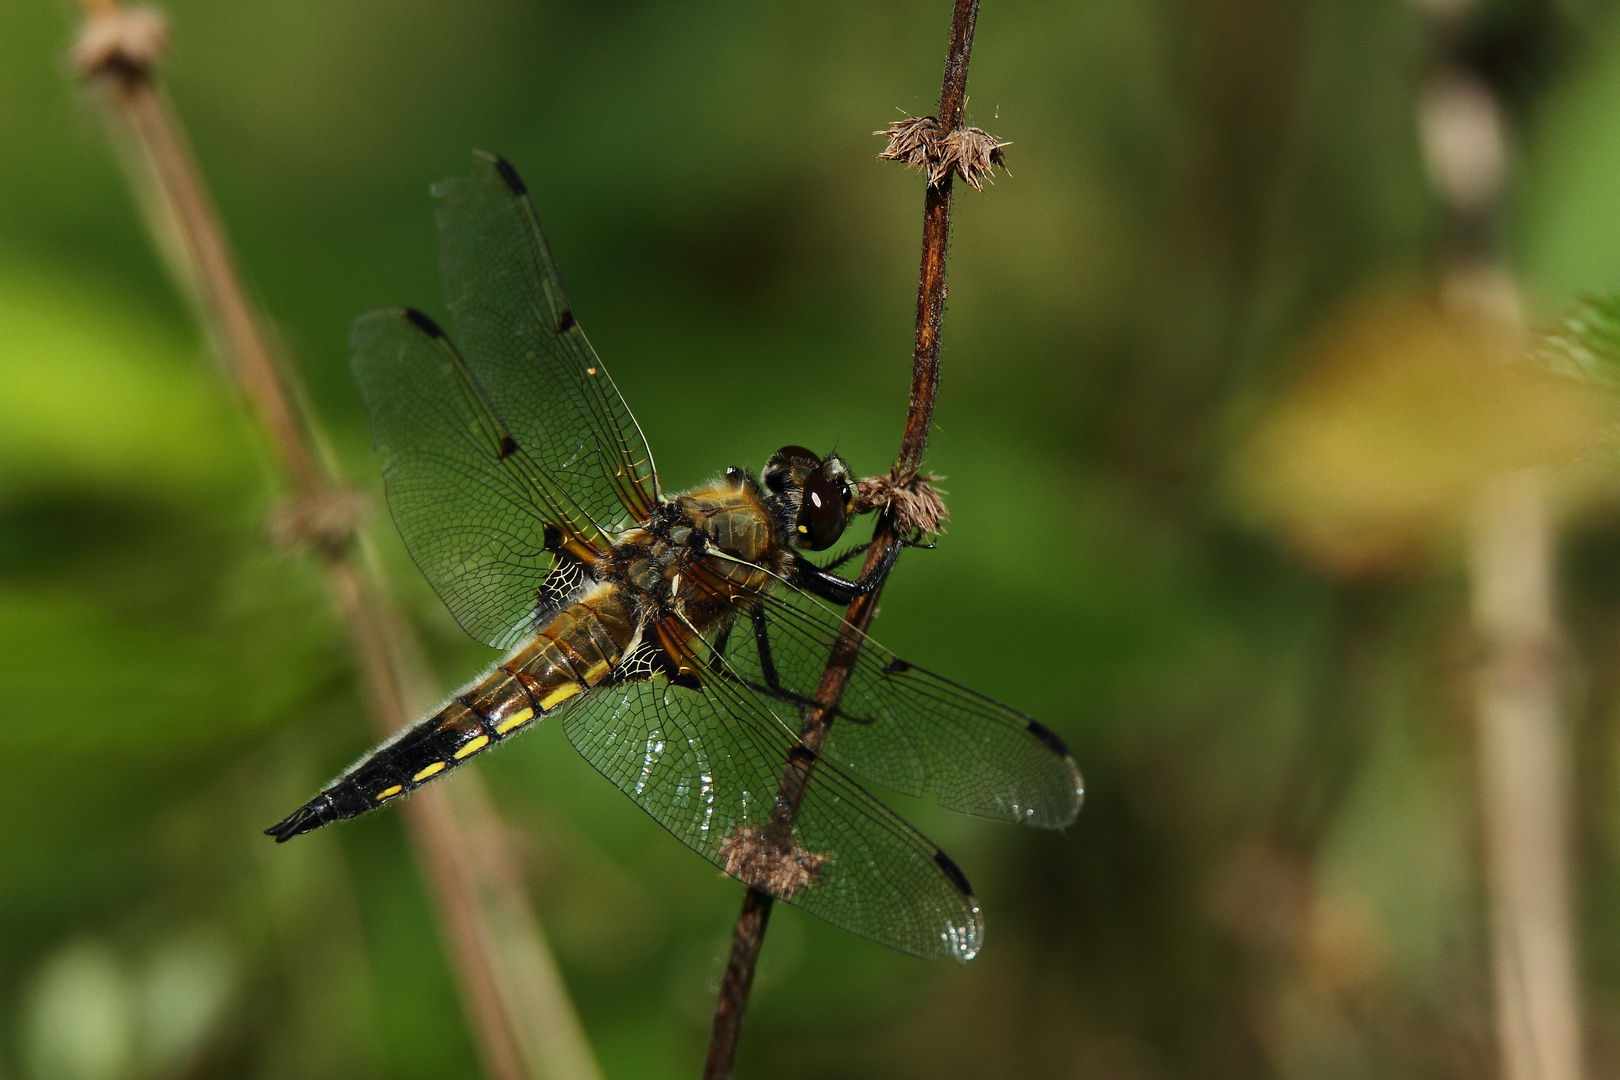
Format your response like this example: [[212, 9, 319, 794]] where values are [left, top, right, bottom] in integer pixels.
[[350, 309, 608, 648]]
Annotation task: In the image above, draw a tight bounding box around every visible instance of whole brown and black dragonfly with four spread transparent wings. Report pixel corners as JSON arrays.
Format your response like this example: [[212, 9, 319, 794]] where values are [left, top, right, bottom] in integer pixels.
[[266, 152, 1084, 962]]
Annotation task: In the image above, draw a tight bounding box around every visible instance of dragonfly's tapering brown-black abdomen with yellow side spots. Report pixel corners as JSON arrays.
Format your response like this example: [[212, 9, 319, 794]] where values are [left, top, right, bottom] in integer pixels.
[[266, 588, 635, 842]]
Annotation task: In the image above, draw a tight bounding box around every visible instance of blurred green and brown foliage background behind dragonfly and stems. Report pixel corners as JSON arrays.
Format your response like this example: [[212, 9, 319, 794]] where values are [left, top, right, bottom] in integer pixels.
[[9, 0, 1620, 1080]]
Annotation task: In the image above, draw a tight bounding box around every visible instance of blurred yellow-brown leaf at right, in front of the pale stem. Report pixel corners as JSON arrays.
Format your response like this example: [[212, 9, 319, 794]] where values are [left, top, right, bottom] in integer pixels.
[[1233, 286, 1607, 575]]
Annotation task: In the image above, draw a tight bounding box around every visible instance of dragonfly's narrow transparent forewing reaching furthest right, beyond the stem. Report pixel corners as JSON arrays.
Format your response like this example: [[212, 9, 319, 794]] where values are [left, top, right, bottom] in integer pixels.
[[716, 588, 1084, 829]]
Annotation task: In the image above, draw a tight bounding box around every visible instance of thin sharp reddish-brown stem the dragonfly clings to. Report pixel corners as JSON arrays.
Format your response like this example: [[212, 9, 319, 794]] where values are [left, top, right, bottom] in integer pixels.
[[703, 0, 978, 1080]]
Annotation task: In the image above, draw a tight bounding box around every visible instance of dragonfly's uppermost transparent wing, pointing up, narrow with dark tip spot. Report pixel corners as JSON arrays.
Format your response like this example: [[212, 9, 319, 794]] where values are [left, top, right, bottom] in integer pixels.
[[434, 152, 658, 531]]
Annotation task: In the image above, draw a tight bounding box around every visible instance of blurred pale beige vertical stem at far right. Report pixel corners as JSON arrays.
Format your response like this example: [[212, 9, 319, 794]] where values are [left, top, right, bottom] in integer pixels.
[[1418, 0, 1583, 1080]]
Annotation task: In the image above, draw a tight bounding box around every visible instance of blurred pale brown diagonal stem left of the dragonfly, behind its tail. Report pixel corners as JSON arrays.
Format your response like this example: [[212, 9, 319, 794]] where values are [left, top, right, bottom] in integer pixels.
[[76, 8, 599, 1080]]
